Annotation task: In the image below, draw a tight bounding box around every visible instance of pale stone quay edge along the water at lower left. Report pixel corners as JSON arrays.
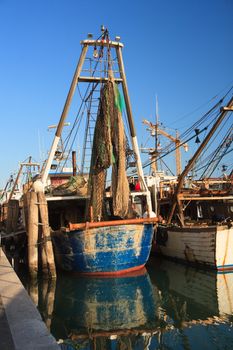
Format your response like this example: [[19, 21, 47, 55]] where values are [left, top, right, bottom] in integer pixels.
[[0, 248, 61, 350]]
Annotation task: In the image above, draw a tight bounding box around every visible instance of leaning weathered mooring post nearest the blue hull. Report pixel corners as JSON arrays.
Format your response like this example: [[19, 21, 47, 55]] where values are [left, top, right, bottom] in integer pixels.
[[37, 192, 56, 278]]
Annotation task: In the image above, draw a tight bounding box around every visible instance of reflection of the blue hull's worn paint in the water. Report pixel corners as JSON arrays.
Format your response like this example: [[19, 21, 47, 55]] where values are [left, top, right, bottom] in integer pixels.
[[53, 271, 159, 338]]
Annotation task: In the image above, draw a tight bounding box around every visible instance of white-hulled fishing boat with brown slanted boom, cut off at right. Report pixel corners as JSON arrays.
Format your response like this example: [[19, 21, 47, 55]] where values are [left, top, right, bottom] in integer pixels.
[[156, 98, 233, 272]]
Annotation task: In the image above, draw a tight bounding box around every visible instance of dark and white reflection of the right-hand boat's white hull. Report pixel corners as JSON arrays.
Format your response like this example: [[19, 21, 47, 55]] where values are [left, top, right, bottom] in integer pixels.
[[148, 260, 233, 328]]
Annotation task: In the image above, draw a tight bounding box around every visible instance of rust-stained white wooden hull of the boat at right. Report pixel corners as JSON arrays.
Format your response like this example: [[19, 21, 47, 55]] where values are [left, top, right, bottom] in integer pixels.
[[156, 225, 233, 272]]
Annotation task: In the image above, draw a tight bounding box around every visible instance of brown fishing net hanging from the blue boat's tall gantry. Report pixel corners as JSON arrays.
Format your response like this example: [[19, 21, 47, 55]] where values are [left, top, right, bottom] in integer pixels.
[[88, 81, 129, 221]]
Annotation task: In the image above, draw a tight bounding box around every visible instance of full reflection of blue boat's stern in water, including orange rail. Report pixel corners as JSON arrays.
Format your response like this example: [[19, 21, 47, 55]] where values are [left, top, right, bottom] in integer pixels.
[[51, 269, 162, 349]]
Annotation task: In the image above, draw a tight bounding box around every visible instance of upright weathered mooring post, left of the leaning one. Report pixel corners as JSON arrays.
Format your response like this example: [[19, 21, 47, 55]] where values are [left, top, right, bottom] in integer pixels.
[[28, 192, 38, 278]]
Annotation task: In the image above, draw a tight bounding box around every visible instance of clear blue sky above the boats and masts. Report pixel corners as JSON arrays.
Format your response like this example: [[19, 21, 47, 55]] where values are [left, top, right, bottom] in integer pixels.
[[0, 0, 233, 187]]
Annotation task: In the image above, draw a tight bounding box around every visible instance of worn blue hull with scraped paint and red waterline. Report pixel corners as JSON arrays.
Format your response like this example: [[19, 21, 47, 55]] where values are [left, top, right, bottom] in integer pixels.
[[52, 224, 154, 274]]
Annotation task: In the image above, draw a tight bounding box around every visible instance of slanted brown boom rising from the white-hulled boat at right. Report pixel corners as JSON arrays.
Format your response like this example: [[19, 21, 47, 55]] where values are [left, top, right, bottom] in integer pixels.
[[168, 97, 233, 226]]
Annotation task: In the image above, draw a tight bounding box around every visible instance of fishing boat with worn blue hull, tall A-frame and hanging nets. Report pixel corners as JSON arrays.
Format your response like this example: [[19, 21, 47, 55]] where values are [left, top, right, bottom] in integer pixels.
[[34, 28, 157, 275]]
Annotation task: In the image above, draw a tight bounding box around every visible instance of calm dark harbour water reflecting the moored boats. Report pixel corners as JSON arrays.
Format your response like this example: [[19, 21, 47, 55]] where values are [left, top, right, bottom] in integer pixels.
[[19, 259, 233, 350]]
